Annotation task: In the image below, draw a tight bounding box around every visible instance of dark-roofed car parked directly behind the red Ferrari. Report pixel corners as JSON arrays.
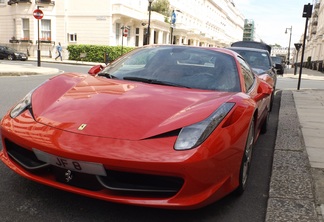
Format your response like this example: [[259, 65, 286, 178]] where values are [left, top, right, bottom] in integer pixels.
[[229, 41, 277, 107]]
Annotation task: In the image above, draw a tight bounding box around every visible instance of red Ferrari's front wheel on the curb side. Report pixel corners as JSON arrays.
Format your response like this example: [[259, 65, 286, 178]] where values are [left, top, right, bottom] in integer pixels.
[[236, 119, 254, 195]]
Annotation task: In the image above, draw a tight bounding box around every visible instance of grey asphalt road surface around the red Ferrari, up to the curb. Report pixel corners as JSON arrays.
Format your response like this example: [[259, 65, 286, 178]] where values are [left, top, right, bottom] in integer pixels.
[[0, 64, 281, 222]]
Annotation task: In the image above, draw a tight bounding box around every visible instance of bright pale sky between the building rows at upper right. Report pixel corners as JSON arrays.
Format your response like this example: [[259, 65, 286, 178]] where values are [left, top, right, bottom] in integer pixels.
[[234, 0, 314, 47]]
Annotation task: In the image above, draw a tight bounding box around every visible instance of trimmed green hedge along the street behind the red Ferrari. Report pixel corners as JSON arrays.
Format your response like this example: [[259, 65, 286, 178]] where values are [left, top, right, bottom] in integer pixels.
[[67, 45, 135, 63]]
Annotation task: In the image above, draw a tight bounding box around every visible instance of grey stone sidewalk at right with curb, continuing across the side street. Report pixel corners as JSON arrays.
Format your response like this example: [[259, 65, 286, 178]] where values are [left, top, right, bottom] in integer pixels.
[[266, 68, 324, 222]]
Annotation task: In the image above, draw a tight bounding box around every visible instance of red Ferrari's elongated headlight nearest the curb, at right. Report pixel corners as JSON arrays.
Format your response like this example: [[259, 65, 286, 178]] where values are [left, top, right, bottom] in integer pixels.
[[174, 103, 235, 150]]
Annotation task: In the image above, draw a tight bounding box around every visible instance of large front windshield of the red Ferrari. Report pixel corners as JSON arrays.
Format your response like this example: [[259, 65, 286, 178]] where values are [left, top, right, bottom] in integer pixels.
[[99, 46, 240, 92]]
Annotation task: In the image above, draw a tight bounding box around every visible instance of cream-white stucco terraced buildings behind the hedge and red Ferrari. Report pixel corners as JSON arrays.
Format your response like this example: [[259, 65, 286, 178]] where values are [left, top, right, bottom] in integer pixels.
[[0, 0, 244, 57]]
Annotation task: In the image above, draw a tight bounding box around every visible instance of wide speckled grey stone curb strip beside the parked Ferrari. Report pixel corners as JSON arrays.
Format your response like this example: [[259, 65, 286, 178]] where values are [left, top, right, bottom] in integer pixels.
[[266, 90, 319, 222]]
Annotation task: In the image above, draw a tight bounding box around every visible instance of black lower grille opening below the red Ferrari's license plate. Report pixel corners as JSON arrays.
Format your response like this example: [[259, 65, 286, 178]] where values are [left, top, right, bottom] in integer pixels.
[[5, 140, 184, 197]]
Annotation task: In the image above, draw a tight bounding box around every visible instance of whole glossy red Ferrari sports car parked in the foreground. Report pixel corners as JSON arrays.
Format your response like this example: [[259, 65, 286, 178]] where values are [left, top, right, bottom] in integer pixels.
[[0, 45, 272, 209]]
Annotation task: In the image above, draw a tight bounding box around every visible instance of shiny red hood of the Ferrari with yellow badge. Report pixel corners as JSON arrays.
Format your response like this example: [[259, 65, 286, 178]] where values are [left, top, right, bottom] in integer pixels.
[[32, 73, 235, 140]]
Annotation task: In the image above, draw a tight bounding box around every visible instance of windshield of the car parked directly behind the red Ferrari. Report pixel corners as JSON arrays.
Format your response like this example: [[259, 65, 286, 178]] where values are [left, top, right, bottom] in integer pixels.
[[234, 49, 271, 70]]
